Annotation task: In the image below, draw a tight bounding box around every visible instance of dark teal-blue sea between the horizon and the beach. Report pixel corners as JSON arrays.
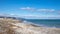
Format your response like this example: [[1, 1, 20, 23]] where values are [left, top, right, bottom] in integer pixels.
[[26, 19, 60, 28]]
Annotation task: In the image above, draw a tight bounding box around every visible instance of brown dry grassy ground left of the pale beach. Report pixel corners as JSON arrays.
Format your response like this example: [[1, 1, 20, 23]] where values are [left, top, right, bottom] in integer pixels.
[[0, 18, 20, 34]]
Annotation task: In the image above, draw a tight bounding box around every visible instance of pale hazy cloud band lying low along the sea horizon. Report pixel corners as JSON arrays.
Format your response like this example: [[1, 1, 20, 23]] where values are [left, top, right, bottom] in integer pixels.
[[21, 14, 60, 19]]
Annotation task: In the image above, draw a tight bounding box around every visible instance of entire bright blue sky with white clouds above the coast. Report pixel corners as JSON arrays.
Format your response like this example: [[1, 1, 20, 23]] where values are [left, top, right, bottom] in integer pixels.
[[0, 0, 60, 19]]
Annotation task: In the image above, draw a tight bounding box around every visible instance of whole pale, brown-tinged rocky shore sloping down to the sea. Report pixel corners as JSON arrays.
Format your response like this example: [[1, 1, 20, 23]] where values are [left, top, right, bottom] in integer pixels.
[[0, 18, 60, 34]]
